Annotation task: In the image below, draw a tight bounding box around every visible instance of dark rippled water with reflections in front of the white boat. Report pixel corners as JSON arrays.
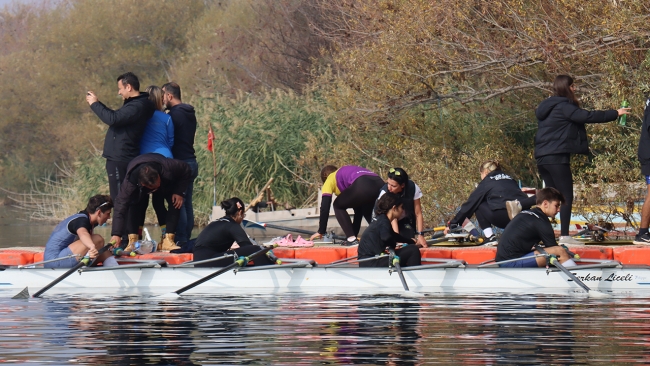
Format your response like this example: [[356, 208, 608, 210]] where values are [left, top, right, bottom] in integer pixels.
[[0, 294, 650, 365]]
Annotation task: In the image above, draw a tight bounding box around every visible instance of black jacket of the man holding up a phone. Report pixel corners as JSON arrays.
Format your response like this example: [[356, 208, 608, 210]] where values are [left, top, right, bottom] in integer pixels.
[[90, 93, 156, 162]]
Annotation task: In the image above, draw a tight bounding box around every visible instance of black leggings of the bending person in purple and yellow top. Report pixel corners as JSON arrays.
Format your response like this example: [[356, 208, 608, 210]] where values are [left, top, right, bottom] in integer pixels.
[[332, 175, 384, 237]]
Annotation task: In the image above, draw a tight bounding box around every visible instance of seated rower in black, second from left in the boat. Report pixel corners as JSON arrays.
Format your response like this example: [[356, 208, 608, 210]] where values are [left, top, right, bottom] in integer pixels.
[[194, 197, 273, 267]]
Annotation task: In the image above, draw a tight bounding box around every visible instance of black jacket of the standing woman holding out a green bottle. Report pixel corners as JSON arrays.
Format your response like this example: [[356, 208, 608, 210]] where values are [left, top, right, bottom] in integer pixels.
[[535, 97, 618, 158]]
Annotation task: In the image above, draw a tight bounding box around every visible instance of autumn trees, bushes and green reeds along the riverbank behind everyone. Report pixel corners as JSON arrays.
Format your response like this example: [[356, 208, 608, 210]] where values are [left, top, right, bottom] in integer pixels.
[[0, 0, 650, 224]]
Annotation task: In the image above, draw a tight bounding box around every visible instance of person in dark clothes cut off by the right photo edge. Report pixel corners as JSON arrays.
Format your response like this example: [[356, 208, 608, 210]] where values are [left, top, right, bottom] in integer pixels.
[[633, 97, 650, 245]]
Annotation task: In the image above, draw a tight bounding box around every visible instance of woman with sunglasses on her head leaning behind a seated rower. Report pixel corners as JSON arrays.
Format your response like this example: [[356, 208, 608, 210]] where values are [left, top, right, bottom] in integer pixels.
[[373, 168, 427, 248]]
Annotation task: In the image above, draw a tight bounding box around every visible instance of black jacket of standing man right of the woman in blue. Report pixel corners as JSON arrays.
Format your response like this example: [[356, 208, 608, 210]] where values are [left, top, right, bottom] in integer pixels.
[[169, 103, 196, 160]]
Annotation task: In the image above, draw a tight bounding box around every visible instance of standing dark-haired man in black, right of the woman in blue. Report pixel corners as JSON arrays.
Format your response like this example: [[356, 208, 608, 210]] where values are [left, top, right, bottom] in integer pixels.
[[162, 82, 199, 243]]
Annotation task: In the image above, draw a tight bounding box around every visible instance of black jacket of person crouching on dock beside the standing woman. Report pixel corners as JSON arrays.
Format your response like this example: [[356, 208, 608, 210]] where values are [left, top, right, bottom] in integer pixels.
[[449, 169, 528, 225]]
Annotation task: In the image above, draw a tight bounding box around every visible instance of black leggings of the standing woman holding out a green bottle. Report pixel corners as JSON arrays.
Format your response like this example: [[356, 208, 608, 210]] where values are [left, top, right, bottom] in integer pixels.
[[537, 164, 573, 236]]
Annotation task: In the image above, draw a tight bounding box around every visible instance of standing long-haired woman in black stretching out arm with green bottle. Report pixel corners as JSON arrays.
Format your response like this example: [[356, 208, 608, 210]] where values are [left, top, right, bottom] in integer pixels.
[[535, 75, 630, 245]]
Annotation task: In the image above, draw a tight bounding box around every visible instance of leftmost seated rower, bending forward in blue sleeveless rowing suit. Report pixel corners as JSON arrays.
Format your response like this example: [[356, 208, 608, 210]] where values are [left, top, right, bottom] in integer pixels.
[[43, 195, 113, 268]]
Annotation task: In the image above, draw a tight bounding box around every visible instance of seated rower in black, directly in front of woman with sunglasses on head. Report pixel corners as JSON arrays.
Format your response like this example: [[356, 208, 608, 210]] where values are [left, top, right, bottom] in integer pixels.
[[359, 192, 422, 267]]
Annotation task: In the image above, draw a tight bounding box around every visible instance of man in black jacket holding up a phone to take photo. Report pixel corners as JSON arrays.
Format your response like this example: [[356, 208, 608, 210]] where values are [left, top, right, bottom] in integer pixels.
[[86, 72, 156, 201]]
